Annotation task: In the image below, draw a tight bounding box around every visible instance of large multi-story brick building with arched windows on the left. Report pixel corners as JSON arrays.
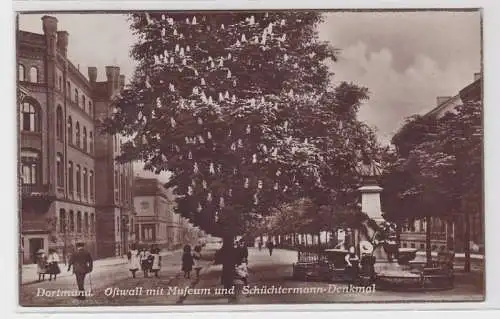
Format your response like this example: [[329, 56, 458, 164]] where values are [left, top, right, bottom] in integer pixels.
[[17, 16, 133, 262]]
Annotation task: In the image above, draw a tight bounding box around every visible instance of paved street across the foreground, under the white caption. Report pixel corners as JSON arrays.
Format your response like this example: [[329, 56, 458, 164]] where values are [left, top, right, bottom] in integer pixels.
[[21, 248, 482, 306]]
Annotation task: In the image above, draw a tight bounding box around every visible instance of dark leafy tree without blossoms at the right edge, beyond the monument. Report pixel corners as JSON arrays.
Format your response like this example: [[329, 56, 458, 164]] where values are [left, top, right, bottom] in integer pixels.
[[384, 101, 483, 270]]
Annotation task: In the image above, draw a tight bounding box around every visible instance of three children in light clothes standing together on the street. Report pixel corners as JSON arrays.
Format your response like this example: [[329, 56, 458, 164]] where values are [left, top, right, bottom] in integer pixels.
[[127, 245, 161, 278]]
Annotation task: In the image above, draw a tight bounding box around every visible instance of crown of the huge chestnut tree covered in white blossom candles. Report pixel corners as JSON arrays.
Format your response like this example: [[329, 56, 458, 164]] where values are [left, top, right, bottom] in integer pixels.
[[105, 11, 377, 245]]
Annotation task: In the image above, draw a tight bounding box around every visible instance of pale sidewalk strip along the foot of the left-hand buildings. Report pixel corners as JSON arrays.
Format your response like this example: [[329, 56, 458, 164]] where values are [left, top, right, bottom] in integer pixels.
[[21, 250, 177, 285]]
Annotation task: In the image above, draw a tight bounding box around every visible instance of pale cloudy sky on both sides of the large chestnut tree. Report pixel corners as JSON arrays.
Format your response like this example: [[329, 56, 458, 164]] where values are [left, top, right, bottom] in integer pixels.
[[19, 11, 481, 180]]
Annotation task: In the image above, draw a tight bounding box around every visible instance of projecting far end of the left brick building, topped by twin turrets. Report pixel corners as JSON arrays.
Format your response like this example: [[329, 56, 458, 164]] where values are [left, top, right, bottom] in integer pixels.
[[92, 66, 135, 257]]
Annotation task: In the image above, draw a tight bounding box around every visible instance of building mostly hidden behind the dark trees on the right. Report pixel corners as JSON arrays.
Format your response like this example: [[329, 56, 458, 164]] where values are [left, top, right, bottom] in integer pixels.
[[400, 73, 484, 252]]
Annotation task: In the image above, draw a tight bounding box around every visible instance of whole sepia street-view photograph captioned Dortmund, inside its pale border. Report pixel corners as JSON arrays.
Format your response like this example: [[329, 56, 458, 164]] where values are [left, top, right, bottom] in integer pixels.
[[13, 8, 486, 308]]
